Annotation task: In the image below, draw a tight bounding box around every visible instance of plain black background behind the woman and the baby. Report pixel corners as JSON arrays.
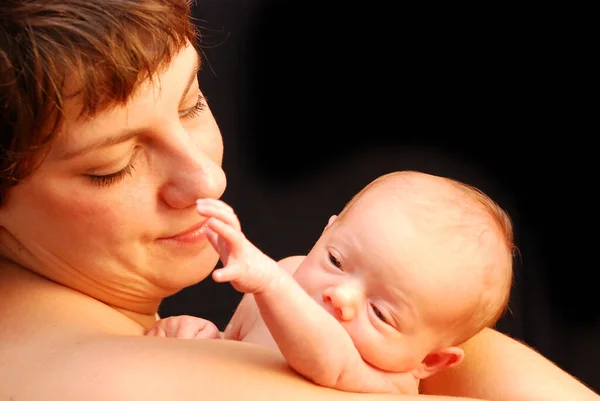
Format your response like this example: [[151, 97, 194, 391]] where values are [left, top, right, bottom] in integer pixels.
[[160, 0, 600, 391]]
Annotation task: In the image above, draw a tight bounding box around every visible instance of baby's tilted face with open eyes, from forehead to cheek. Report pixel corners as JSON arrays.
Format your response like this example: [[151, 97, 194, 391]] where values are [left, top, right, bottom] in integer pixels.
[[294, 183, 476, 372]]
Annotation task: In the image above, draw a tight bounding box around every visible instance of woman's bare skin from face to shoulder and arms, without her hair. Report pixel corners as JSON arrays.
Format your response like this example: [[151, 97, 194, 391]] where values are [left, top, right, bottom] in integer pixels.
[[0, 22, 598, 401]]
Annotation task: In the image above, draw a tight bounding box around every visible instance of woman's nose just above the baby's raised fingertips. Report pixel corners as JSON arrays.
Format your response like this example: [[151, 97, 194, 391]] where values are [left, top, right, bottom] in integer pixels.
[[161, 130, 227, 209]]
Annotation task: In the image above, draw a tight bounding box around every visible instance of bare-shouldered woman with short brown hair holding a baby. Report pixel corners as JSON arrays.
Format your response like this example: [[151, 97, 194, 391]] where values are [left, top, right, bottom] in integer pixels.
[[0, 0, 598, 401]]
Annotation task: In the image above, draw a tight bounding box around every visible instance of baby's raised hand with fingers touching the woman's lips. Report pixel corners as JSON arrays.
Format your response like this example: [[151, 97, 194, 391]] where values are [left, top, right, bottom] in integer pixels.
[[196, 199, 287, 294]]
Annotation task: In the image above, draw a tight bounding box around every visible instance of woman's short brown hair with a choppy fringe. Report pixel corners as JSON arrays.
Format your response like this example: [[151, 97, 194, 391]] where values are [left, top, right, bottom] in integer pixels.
[[0, 0, 197, 207]]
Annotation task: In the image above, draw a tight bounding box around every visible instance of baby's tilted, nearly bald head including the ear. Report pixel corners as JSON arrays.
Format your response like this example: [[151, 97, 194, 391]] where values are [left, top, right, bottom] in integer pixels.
[[295, 171, 513, 378]]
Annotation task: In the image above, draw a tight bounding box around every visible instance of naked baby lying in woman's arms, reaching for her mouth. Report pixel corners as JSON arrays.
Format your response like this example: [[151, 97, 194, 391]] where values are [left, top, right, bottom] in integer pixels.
[[147, 171, 513, 394]]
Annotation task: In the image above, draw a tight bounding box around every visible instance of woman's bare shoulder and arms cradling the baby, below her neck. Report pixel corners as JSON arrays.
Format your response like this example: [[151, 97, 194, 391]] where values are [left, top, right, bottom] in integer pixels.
[[0, 250, 600, 401]]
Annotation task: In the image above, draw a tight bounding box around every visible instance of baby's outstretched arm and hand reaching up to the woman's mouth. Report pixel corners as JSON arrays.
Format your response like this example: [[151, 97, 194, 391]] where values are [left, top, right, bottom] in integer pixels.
[[197, 199, 398, 392]]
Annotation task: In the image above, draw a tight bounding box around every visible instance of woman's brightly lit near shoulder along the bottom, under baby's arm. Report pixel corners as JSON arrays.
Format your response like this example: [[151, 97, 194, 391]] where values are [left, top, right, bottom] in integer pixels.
[[0, 336, 488, 401]]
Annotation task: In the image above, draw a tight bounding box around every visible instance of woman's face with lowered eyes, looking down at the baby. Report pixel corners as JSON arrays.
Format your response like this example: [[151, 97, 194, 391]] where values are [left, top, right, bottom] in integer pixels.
[[0, 46, 226, 313]]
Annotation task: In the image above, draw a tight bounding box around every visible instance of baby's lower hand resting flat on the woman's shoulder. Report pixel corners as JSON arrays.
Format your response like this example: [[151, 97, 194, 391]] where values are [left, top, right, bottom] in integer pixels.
[[146, 315, 221, 340]]
